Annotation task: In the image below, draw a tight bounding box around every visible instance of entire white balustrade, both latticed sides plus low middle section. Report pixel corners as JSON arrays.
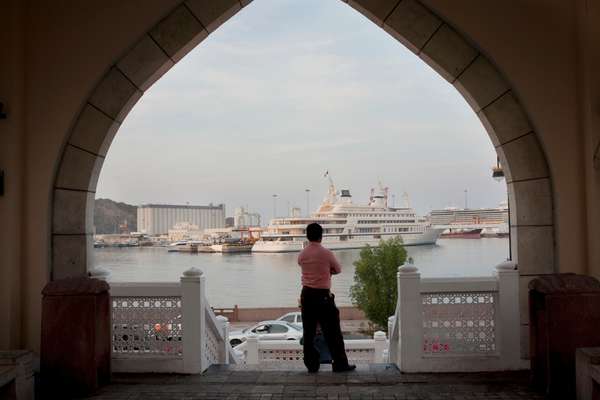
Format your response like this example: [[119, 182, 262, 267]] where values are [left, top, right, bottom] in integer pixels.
[[90, 262, 527, 373]]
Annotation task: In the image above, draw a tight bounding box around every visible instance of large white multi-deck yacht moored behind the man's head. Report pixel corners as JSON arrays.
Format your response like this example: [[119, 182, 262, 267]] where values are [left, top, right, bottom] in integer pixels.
[[252, 179, 443, 253]]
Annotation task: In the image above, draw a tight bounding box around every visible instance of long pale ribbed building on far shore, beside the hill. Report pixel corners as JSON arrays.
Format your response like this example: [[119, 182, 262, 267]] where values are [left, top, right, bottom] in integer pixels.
[[137, 204, 225, 235]]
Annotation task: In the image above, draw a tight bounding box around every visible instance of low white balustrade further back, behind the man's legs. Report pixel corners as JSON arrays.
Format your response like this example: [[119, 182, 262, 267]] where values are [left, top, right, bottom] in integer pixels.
[[235, 331, 388, 365]]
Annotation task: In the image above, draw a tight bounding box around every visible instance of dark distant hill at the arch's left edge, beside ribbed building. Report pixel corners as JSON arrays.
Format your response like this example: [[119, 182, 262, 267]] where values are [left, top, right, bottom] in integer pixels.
[[94, 199, 137, 234]]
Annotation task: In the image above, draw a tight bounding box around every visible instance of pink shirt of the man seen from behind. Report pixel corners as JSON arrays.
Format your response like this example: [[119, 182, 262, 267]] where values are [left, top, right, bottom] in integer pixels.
[[298, 242, 342, 289]]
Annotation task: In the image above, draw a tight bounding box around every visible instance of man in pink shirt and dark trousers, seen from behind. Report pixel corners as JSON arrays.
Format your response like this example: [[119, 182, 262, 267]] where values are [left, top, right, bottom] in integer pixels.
[[298, 223, 356, 372]]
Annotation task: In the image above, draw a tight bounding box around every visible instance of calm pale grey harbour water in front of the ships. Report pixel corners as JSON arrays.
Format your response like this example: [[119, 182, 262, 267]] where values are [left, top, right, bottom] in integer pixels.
[[94, 238, 508, 307]]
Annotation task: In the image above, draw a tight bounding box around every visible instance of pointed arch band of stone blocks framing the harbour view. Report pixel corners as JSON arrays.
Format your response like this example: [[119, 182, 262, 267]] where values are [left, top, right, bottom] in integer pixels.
[[50, 0, 555, 351]]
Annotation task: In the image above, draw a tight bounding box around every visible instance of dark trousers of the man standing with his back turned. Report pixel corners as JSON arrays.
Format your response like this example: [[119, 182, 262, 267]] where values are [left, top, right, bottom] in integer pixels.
[[300, 286, 348, 371]]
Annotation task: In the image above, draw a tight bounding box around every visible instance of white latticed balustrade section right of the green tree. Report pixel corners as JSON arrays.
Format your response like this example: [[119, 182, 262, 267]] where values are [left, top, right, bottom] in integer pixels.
[[388, 262, 526, 372]]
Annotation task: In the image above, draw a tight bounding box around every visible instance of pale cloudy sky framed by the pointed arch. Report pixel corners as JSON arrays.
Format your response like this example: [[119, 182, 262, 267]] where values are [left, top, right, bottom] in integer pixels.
[[96, 0, 506, 222]]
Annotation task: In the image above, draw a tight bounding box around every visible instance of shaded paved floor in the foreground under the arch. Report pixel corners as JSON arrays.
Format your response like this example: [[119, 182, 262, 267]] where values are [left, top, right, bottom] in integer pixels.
[[78, 364, 544, 400]]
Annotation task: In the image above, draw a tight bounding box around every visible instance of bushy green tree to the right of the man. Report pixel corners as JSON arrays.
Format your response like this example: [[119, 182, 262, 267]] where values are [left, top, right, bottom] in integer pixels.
[[350, 238, 406, 330]]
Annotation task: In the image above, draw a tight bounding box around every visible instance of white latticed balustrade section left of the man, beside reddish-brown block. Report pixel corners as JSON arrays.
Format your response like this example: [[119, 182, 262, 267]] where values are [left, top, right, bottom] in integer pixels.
[[90, 268, 236, 374]]
